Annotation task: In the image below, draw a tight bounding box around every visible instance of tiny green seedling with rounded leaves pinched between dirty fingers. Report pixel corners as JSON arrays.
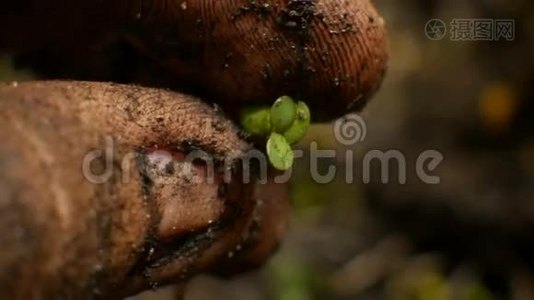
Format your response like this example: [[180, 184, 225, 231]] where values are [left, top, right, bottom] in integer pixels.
[[241, 96, 311, 171]]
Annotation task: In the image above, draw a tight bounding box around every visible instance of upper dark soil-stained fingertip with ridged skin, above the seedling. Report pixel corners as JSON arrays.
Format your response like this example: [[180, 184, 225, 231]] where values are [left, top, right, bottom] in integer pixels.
[[0, 0, 388, 121]]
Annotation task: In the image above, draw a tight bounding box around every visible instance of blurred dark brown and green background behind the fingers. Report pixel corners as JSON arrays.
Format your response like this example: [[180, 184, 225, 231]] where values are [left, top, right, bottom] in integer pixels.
[[0, 0, 534, 300]]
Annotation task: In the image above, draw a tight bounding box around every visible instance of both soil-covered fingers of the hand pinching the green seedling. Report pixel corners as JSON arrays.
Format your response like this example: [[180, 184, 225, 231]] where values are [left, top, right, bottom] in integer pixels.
[[0, 0, 387, 299]]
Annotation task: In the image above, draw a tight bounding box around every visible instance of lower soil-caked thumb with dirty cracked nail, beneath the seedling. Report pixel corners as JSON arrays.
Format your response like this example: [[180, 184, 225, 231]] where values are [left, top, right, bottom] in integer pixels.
[[0, 82, 287, 299]]
